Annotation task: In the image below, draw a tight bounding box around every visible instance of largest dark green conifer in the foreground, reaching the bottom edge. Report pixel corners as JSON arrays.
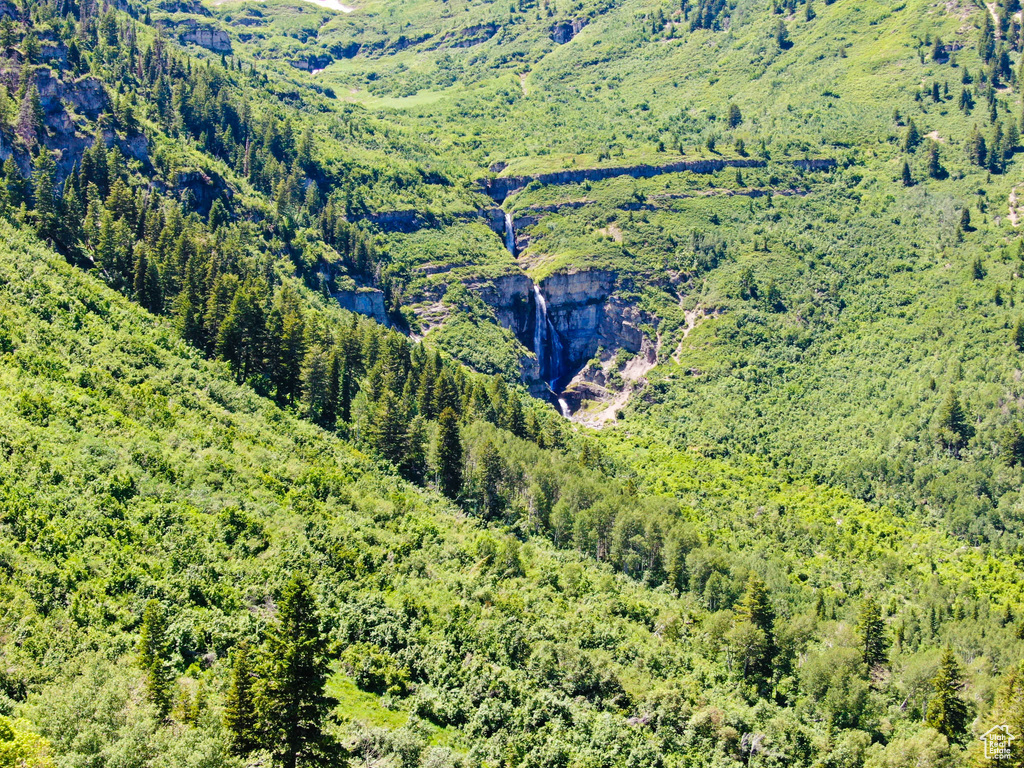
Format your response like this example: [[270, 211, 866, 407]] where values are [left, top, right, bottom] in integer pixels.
[[256, 574, 333, 768]]
